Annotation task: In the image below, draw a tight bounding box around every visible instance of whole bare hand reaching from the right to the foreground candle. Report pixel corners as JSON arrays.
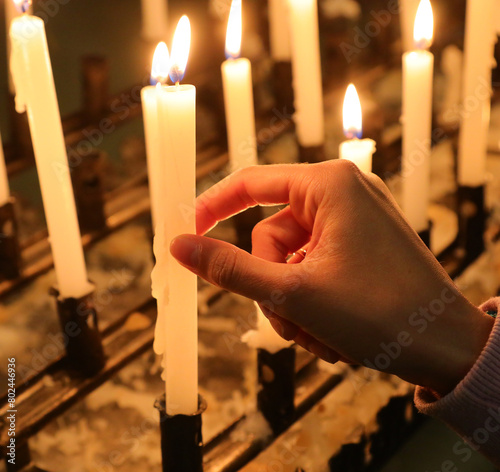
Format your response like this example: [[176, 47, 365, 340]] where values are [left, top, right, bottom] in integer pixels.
[[171, 160, 493, 393]]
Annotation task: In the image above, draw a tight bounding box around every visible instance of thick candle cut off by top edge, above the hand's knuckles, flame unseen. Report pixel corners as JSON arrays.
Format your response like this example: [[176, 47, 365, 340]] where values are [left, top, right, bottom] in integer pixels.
[[289, 0, 325, 147]]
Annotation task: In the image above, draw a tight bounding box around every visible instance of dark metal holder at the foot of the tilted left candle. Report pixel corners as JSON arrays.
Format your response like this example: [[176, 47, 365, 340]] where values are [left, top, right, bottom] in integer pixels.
[[51, 288, 106, 377]]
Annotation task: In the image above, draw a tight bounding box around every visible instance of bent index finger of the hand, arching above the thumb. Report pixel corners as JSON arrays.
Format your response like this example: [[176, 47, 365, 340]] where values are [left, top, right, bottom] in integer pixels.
[[196, 164, 305, 234]]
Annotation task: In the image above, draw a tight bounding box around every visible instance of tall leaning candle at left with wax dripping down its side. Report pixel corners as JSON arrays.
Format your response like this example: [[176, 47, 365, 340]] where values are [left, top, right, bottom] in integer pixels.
[[10, 0, 92, 298]]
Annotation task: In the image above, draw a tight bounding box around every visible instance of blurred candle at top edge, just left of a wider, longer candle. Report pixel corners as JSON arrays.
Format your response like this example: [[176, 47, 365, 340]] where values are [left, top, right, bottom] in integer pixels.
[[268, 0, 292, 62]]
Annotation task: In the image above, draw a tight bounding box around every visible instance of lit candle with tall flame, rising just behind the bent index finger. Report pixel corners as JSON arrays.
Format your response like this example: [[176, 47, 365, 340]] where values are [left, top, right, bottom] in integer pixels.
[[221, 0, 257, 172]]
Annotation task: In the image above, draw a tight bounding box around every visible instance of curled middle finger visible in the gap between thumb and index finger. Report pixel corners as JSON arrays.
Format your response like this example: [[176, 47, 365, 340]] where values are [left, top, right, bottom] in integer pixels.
[[252, 207, 310, 263]]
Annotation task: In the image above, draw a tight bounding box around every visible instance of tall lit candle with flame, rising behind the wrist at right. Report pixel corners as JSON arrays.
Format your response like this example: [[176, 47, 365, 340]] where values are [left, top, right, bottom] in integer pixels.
[[401, 0, 434, 232]]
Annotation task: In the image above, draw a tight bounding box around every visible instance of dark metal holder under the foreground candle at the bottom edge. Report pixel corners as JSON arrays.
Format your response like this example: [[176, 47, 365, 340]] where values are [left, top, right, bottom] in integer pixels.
[[155, 395, 207, 472]]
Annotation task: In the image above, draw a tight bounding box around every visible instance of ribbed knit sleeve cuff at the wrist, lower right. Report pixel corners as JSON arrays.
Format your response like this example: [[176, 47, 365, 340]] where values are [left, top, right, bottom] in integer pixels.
[[415, 297, 500, 467]]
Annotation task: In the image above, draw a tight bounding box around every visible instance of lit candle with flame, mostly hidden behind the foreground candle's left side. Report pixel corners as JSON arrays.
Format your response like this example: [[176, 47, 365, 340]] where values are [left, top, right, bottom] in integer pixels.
[[141, 42, 169, 231]]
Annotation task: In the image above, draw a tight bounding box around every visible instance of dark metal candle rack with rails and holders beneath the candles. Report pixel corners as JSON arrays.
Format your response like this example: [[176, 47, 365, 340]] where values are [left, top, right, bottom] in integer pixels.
[[0, 40, 492, 472]]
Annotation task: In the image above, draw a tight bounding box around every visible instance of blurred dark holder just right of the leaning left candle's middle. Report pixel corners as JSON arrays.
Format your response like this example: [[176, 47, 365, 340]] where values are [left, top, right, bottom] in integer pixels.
[[71, 151, 106, 233]]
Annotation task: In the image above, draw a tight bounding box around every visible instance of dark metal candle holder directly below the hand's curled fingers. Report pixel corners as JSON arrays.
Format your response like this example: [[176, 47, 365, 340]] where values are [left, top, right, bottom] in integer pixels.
[[257, 347, 296, 435]]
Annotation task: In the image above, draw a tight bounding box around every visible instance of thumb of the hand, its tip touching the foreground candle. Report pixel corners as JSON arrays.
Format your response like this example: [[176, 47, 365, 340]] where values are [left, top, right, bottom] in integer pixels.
[[170, 234, 300, 301]]
